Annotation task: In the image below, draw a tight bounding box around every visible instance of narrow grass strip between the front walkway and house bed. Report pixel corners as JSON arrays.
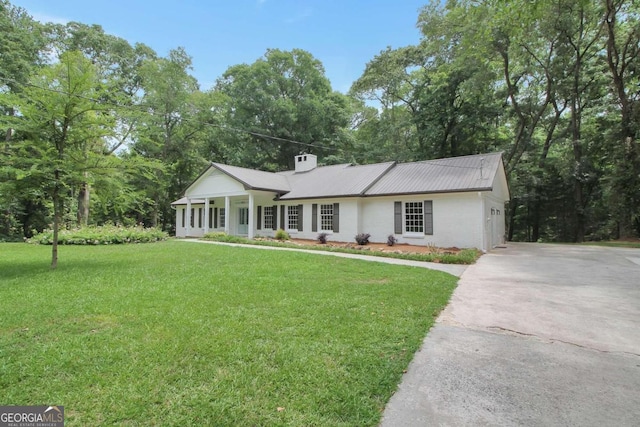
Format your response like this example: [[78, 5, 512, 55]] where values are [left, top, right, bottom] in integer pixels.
[[202, 232, 482, 265]]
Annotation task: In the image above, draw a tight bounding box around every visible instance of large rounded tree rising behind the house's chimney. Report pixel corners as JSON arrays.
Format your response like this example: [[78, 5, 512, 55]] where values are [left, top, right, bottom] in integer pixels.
[[216, 49, 350, 169]]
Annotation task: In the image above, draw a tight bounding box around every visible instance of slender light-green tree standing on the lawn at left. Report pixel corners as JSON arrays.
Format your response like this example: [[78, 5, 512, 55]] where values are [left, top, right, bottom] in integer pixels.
[[3, 52, 114, 268]]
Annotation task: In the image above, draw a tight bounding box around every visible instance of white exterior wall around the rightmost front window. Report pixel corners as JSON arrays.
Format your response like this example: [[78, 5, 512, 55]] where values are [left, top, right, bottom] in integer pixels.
[[362, 193, 483, 249]]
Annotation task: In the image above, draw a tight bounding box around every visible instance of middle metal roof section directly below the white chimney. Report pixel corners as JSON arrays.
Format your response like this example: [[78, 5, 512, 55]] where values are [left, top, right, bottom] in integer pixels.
[[278, 162, 395, 200]]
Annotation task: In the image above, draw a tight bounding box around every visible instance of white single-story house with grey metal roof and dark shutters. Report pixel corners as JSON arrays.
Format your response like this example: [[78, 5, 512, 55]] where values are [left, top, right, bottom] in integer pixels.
[[172, 153, 509, 251]]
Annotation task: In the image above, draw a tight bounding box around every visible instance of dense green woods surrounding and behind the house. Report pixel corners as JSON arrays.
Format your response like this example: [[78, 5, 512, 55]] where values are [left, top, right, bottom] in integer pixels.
[[0, 0, 640, 242]]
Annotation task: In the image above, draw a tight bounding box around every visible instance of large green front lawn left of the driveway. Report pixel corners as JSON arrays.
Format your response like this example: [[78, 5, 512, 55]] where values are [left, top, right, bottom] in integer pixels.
[[0, 241, 456, 426]]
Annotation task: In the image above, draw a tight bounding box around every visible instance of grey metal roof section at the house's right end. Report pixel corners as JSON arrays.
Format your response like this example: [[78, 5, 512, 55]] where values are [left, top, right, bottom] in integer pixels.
[[366, 153, 502, 196]]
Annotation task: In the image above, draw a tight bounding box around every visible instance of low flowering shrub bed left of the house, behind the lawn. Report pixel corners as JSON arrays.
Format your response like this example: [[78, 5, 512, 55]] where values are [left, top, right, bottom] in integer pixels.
[[27, 225, 169, 245]]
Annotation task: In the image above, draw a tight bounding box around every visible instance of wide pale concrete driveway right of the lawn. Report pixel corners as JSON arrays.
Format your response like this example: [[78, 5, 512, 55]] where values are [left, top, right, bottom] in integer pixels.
[[382, 243, 640, 427]]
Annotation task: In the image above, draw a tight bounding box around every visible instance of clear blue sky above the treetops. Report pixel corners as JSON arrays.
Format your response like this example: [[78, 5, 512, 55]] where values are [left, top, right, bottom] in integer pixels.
[[10, 0, 429, 93]]
